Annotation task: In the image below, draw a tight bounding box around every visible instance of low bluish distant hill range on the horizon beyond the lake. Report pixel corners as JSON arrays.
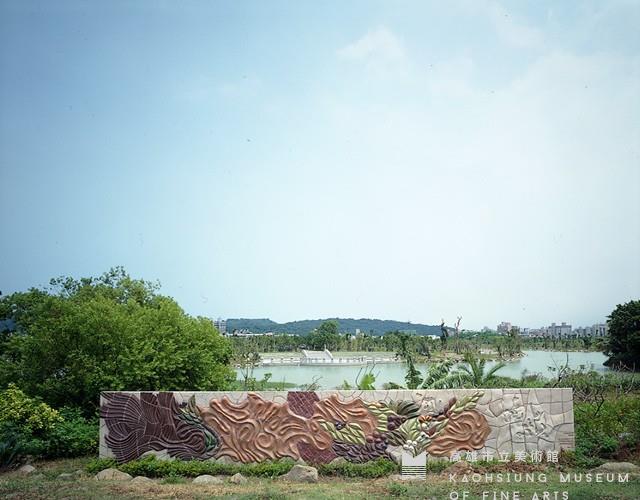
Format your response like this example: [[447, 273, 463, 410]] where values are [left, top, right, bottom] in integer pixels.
[[227, 318, 440, 335]]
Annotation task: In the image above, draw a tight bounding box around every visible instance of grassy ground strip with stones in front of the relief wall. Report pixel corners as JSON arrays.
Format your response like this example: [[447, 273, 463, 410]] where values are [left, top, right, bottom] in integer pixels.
[[0, 459, 640, 500]]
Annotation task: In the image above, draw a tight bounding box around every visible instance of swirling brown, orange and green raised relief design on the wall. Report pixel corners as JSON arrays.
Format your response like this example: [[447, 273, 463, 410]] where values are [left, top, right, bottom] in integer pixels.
[[101, 391, 490, 463]]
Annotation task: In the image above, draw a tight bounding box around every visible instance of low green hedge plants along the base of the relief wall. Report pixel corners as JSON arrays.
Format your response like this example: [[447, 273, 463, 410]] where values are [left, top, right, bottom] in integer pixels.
[[86, 456, 399, 478]]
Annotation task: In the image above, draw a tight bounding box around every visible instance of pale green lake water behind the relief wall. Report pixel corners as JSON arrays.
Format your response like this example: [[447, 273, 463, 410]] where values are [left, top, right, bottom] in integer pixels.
[[241, 351, 607, 389]]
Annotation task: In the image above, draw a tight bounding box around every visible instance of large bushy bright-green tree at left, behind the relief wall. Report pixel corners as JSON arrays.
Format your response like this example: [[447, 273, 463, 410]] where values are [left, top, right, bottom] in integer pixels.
[[0, 268, 234, 414]]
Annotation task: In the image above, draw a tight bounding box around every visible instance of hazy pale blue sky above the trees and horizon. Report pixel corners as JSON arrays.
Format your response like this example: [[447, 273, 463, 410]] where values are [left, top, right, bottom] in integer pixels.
[[0, 0, 640, 329]]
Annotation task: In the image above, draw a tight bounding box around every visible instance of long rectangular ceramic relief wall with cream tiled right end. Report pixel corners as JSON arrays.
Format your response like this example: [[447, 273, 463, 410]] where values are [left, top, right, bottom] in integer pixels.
[[100, 389, 574, 464]]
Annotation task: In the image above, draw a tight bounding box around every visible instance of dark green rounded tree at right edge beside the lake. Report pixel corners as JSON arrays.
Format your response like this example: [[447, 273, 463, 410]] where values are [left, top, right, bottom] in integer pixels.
[[604, 300, 640, 371]]
